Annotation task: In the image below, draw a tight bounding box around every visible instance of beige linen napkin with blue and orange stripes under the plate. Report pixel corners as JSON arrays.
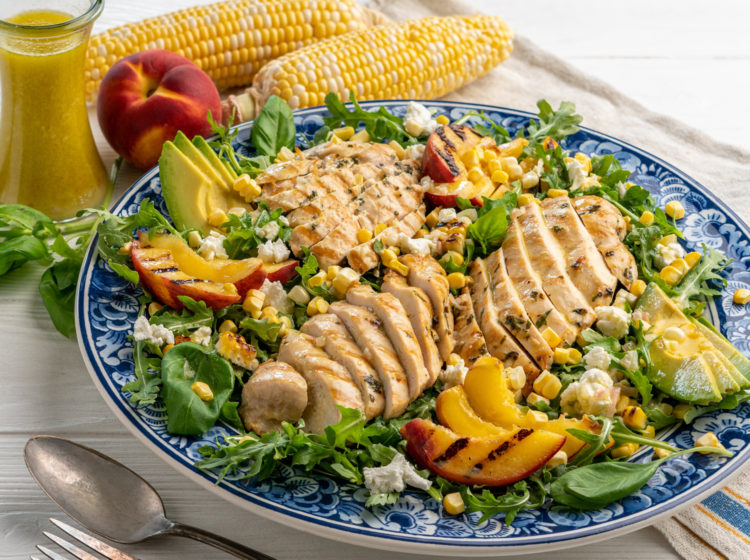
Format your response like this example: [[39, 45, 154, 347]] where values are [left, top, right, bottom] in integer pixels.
[[365, 0, 750, 560]]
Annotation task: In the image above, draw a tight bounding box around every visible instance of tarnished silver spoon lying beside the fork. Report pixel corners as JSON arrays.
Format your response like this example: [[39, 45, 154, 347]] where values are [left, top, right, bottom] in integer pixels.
[[23, 436, 274, 560]]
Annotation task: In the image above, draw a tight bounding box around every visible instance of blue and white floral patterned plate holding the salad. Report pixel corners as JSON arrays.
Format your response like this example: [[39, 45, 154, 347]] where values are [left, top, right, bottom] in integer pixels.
[[76, 101, 750, 556]]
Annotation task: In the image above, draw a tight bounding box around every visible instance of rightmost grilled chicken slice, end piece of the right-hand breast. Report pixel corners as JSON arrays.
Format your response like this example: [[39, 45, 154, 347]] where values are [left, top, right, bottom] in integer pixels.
[[573, 196, 638, 289]]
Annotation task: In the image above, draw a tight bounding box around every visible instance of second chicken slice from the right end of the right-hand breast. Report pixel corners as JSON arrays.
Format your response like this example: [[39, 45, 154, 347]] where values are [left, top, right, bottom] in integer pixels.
[[542, 196, 617, 307]]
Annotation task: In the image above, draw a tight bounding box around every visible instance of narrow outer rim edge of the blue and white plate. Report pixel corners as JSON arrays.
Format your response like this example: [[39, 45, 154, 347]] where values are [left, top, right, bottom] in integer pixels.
[[75, 99, 750, 556]]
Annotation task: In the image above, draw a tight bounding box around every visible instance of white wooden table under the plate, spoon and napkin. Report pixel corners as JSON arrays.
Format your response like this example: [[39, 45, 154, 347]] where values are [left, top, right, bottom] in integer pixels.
[[0, 0, 750, 560]]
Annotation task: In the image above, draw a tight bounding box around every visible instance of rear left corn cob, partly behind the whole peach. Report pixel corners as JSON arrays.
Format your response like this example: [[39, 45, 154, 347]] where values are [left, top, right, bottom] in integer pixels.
[[86, 0, 385, 101]]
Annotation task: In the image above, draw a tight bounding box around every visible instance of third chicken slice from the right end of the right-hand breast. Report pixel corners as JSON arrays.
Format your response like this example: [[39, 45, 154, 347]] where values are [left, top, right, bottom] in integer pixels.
[[511, 203, 596, 329]]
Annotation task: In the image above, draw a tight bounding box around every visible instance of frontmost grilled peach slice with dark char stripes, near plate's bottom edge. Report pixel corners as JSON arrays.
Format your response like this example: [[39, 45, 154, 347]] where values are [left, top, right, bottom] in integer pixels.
[[401, 418, 565, 486]]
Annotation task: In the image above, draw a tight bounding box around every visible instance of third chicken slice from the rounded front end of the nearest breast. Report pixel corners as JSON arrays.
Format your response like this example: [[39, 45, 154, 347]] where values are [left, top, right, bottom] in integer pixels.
[[300, 313, 385, 420]]
